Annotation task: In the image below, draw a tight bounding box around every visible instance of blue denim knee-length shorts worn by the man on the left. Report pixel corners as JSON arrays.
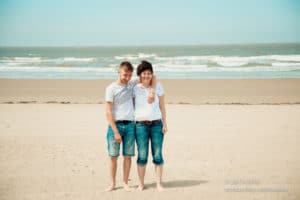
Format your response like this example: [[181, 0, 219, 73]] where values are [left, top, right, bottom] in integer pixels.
[[106, 122, 135, 157]]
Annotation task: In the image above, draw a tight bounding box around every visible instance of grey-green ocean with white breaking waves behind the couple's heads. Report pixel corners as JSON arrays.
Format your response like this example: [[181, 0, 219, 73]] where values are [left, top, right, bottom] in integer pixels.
[[0, 44, 300, 79]]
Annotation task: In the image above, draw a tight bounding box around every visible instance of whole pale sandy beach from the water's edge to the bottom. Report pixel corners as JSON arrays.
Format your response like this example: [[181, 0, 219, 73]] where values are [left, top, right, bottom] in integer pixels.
[[0, 79, 300, 200]]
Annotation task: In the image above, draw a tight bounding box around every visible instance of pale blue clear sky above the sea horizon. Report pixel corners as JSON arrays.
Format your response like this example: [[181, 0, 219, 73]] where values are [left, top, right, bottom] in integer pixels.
[[0, 0, 300, 46]]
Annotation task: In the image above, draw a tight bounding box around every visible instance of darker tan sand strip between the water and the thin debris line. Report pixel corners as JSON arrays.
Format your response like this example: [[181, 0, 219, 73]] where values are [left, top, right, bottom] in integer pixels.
[[0, 78, 300, 105]]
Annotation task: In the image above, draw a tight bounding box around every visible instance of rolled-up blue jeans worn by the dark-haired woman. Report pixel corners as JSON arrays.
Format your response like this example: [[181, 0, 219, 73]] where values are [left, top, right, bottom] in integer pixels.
[[135, 121, 164, 166]]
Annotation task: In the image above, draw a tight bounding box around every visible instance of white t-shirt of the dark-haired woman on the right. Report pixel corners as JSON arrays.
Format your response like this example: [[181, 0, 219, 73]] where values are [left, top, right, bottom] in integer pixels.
[[133, 83, 164, 121]]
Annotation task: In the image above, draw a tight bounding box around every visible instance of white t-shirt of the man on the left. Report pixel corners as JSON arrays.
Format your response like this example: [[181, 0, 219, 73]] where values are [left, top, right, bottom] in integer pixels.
[[105, 80, 137, 121]]
